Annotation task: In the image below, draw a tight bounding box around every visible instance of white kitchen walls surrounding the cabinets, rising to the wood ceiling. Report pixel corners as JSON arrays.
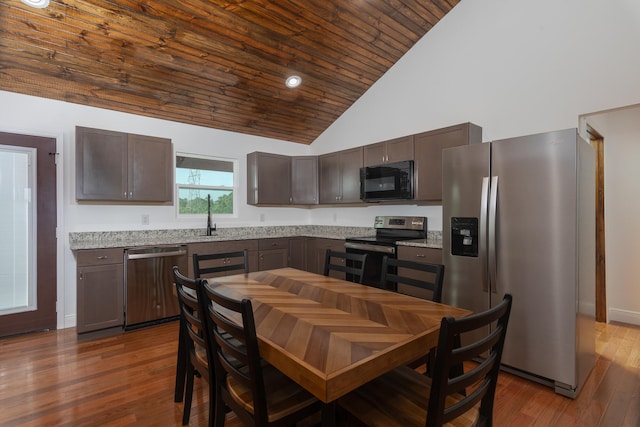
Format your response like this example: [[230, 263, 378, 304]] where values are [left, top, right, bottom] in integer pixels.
[[0, 0, 640, 327]]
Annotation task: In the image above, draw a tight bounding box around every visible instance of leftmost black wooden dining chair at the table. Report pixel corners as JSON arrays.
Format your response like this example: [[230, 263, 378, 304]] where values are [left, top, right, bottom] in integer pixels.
[[173, 266, 215, 425]]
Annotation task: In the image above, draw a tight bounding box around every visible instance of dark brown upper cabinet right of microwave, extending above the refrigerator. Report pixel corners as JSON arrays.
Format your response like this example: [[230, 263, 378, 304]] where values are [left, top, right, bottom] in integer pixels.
[[413, 123, 482, 201]]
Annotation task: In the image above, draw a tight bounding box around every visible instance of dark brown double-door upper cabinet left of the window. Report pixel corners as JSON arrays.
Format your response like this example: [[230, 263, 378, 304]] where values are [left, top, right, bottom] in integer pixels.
[[76, 127, 173, 204]]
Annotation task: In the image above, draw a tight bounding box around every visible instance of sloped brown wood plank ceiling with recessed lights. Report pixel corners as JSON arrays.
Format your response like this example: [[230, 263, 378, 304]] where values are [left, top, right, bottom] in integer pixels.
[[0, 0, 459, 144]]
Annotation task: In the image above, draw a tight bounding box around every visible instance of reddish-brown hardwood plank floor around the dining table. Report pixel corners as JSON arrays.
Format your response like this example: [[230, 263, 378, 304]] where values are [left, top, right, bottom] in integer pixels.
[[0, 322, 640, 427]]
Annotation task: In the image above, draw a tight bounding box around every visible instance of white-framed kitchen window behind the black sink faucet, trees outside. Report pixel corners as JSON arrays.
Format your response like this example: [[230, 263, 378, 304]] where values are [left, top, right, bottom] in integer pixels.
[[176, 153, 238, 216]]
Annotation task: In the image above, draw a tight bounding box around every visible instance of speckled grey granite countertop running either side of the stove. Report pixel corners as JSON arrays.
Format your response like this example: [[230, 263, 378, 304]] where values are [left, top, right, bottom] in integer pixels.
[[69, 225, 442, 251]]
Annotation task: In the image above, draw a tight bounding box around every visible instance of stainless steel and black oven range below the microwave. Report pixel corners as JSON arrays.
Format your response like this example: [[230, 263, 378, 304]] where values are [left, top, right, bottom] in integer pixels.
[[344, 216, 427, 288]]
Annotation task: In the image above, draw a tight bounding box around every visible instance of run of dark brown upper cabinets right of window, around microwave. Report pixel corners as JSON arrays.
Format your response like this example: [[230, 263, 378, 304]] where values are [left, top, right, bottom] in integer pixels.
[[247, 123, 482, 206]]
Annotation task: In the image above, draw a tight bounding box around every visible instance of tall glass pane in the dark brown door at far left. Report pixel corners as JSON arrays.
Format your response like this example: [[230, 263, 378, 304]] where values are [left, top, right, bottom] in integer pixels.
[[0, 145, 37, 315]]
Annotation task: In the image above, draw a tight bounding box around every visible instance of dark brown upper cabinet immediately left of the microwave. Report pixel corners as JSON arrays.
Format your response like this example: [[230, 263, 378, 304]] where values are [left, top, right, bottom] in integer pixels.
[[318, 147, 363, 204]]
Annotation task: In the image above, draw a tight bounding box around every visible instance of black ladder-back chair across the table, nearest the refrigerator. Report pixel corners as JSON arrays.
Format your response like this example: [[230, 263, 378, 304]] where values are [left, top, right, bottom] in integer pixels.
[[380, 255, 444, 375]]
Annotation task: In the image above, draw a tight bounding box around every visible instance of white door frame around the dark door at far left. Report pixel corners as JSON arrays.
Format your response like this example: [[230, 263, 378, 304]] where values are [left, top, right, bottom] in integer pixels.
[[0, 126, 64, 329]]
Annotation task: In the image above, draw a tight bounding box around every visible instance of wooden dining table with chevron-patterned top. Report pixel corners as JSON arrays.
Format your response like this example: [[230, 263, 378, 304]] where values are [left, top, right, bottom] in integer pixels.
[[209, 268, 470, 425]]
